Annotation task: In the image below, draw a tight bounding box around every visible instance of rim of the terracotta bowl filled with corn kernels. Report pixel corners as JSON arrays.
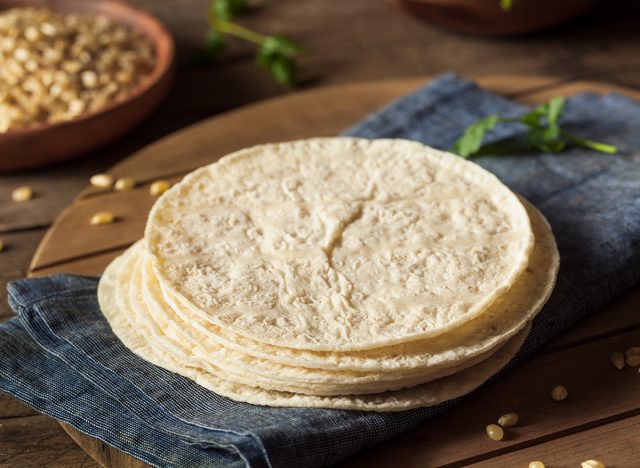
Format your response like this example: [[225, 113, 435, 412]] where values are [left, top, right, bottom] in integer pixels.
[[0, 0, 176, 142]]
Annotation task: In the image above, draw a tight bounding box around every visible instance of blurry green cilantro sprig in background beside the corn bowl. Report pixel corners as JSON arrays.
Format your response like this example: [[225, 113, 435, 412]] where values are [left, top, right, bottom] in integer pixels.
[[199, 0, 303, 86]]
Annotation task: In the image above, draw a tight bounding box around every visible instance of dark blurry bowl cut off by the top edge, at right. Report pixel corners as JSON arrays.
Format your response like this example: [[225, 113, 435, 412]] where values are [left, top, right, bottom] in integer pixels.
[[396, 0, 602, 36]]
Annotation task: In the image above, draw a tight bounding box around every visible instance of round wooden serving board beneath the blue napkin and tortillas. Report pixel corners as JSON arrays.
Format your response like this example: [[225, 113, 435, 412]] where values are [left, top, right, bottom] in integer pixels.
[[29, 76, 640, 467]]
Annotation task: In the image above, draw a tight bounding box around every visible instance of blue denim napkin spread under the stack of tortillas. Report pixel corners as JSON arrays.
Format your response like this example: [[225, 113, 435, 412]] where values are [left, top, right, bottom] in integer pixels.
[[0, 75, 640, 467]]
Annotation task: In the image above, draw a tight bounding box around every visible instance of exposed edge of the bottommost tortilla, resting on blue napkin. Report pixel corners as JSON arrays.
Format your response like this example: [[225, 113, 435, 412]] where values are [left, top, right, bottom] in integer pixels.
[[98, 249, 530, 411]]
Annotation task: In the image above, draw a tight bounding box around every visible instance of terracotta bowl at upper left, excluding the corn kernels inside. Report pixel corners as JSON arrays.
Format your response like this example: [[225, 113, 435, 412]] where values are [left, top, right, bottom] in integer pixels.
[[0, 0, 175, 172]]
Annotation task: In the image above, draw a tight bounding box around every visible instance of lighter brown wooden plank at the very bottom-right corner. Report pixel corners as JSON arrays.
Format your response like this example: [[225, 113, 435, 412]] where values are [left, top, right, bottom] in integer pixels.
[[470, 416, 640, 468]]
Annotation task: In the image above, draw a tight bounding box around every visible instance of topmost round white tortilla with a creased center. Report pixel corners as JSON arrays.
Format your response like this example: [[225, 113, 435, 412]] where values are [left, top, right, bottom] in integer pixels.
[[145, 137, 534, 351]]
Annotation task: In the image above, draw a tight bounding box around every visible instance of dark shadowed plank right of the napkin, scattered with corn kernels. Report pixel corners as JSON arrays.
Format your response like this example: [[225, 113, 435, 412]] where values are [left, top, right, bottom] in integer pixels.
[[343, 330, 640, 467]]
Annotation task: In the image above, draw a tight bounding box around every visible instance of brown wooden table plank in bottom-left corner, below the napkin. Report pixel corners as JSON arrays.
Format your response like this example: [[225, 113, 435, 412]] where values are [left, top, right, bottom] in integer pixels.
[[0, 415, 99, 468]]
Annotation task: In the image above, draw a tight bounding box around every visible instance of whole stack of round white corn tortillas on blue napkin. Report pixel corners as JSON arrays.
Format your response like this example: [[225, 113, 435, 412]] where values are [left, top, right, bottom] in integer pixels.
[[99, 138, 559, 411]]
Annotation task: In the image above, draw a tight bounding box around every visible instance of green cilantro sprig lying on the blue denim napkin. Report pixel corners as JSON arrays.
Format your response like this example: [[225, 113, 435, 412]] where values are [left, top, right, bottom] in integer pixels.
[[451, 97, 618, 158]]
